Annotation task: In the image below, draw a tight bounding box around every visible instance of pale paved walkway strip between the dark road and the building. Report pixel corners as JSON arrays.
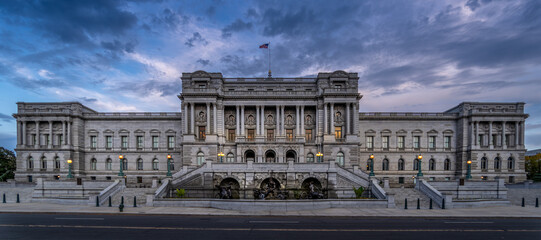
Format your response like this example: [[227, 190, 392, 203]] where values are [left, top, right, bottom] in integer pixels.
[[0, 203, 541, 218]]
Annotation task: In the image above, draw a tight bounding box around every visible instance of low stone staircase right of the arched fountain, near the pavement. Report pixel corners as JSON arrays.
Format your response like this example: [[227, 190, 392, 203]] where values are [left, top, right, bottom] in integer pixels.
[[385, 187, 439, 209]]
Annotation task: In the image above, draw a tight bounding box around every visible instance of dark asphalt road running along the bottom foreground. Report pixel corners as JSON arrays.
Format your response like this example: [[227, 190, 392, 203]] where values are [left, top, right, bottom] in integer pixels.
[[0, 214, 541, 240]]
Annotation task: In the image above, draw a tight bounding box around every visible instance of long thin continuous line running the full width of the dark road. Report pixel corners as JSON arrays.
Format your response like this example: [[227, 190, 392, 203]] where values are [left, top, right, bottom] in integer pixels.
[[0, 224, 541, 232]]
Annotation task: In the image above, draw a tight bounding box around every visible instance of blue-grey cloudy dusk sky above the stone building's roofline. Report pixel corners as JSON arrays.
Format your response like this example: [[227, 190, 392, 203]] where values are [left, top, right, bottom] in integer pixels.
[[0, 0, 541, 149]]
